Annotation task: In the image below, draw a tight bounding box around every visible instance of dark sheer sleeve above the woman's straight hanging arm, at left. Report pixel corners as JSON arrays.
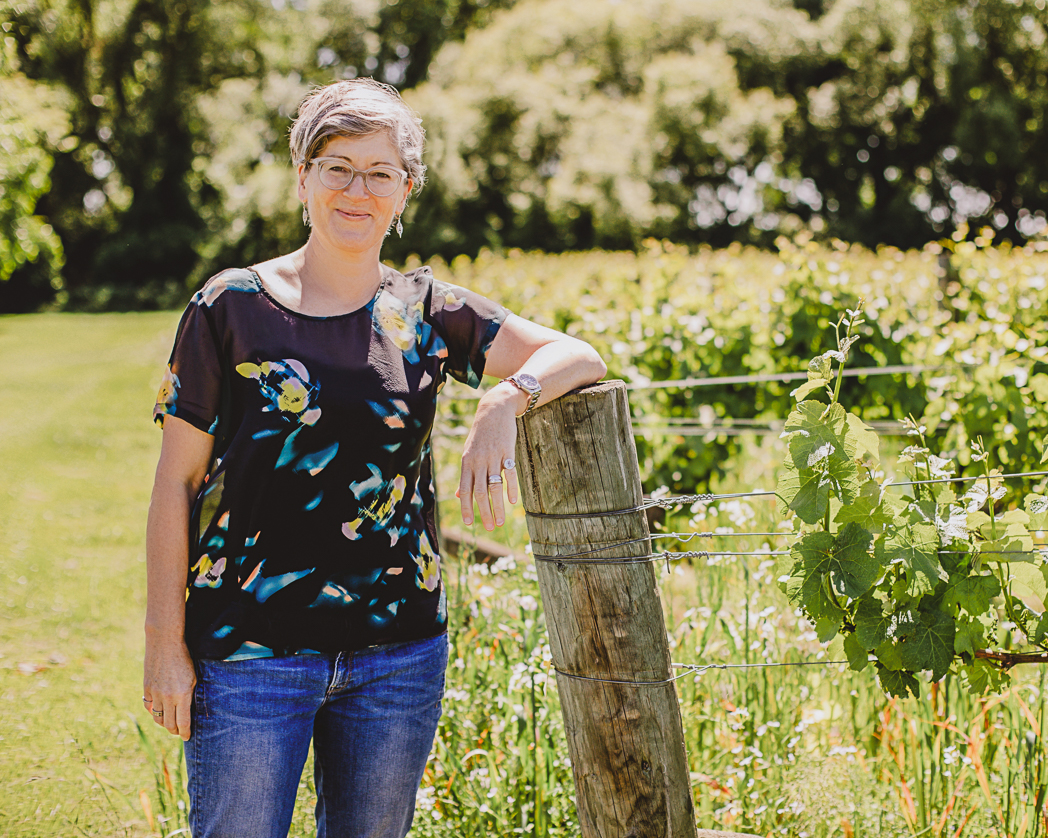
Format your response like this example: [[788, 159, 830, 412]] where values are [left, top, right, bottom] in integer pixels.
[[153, 297, 222, 434]]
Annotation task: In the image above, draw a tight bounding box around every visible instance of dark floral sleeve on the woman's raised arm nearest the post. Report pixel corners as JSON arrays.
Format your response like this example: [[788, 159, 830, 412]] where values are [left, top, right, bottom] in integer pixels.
[[430, 280, 509, 389]]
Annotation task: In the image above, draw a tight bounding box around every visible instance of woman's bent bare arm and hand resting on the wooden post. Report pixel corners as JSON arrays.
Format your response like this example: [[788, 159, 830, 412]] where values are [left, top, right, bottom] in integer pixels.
[[455, 314, 608, 530]]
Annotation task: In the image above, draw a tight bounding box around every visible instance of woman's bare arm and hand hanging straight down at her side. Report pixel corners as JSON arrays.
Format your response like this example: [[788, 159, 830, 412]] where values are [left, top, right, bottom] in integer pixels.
[[141, 416, 215, 740]]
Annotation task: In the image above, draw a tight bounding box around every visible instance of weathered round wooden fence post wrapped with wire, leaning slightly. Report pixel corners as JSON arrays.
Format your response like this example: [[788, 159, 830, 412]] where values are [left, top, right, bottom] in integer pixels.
[[517, 381, 696, 838]]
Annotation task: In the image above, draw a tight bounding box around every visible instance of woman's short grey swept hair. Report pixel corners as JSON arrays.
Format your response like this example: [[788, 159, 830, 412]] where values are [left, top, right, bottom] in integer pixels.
[[290, 79, 425, 191]]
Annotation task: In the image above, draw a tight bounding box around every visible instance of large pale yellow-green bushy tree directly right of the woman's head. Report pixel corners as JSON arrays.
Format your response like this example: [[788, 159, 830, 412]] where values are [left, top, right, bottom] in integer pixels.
[[400, 0, 808, 256]]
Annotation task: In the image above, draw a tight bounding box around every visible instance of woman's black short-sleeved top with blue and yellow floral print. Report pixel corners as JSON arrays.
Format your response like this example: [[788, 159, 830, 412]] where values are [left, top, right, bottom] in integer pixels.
[[153, 265, 508, 660]]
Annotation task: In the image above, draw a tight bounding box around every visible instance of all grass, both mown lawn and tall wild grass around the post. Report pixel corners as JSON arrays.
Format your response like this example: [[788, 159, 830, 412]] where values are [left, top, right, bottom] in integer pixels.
[[0, 313, 1048, 838]]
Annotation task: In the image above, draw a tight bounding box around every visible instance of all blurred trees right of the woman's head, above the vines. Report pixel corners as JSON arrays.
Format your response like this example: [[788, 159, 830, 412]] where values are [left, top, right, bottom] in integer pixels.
[[404, 0, 1048, 258]]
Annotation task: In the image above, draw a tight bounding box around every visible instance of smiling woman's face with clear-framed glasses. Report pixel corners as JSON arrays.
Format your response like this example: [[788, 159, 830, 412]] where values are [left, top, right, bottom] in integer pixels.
[[299, 132, 412, 260]]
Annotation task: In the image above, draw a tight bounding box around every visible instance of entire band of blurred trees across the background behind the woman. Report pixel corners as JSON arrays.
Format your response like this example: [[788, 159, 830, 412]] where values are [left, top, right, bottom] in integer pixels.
[[0, 0, 1048, 311]]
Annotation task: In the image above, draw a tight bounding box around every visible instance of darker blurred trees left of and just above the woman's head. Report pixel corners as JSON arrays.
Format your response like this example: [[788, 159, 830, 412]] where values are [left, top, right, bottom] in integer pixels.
[[0, 0, 505, 310]]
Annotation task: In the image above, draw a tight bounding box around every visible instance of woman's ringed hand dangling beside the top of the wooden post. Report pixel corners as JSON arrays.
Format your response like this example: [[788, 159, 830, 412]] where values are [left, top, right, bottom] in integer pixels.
[[455, 384, 527, 531]]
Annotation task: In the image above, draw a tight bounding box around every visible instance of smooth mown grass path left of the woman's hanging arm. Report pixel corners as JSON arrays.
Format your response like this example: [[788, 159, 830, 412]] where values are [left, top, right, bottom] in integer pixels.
[[0, 312, 178, 838]]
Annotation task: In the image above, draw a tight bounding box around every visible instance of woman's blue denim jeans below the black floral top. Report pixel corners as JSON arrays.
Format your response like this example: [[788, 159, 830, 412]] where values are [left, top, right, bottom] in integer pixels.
[[185, 635, 447, 838]]
